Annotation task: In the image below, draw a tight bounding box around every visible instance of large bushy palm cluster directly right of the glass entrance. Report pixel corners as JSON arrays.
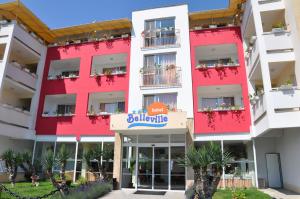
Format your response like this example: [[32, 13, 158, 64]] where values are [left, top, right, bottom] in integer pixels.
[[179, 142, 231, 199]]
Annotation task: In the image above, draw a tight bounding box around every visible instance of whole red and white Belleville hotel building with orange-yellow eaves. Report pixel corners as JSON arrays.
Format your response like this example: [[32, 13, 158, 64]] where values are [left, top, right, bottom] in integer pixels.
[[0, 0, 300, 192]]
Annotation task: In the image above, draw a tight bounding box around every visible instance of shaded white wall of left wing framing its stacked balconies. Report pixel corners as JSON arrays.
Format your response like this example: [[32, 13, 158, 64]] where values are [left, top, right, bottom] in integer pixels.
[[0, 21, 47, 139]]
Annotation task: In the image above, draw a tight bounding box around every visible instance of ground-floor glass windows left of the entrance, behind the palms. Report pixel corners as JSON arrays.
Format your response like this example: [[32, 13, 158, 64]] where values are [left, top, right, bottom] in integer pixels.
[[34, 141, 114, 181]]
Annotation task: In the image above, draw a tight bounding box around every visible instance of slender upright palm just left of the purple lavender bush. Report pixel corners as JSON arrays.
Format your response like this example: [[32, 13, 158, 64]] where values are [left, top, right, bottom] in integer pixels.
[[56, 144, 70, 183]]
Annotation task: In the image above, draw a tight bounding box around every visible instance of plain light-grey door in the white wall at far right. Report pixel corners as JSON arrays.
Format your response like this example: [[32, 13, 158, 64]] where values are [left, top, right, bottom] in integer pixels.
[[266, 153, 282, 188]]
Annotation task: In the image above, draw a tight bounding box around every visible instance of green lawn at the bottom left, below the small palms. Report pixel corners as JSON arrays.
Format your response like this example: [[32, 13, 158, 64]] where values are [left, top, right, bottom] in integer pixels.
[[0, 181, 59, 199]]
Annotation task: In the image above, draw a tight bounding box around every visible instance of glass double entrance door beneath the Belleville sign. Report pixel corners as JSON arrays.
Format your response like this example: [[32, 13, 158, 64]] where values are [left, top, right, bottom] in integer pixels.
[[137, 146, 169, 189]]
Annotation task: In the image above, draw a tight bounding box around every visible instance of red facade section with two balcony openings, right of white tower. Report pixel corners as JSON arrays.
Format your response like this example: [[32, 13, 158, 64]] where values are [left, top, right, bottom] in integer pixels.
[[190, 27, 250, 134]]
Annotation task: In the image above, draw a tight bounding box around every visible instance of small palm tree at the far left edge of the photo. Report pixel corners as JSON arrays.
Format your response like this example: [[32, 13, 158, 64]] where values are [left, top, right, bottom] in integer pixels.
[[2, 149, 22, 187]]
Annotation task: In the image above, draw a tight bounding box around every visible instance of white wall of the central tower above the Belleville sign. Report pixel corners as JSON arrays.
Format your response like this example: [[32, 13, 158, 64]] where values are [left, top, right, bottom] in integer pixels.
[[128, 5, 193, 118]]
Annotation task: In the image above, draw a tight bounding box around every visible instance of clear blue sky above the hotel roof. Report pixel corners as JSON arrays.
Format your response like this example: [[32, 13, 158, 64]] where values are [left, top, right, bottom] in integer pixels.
[[0, 0, 228, 28]]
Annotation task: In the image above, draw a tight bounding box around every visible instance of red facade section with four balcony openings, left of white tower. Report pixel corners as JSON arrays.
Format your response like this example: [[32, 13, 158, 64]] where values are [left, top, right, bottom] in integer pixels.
[[36, 39, 130, 137]]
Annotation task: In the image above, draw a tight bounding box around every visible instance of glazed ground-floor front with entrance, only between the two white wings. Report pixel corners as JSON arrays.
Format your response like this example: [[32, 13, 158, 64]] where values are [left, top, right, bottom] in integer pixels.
[[33, 130, 258, 190]]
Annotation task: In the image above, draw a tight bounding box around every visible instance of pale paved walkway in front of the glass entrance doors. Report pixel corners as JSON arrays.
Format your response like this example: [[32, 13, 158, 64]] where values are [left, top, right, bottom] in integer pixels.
[[101, 189, 185, 199]]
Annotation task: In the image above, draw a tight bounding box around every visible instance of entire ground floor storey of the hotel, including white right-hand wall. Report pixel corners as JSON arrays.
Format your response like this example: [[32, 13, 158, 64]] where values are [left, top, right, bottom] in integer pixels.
[[0, 128, 300, 192]]
